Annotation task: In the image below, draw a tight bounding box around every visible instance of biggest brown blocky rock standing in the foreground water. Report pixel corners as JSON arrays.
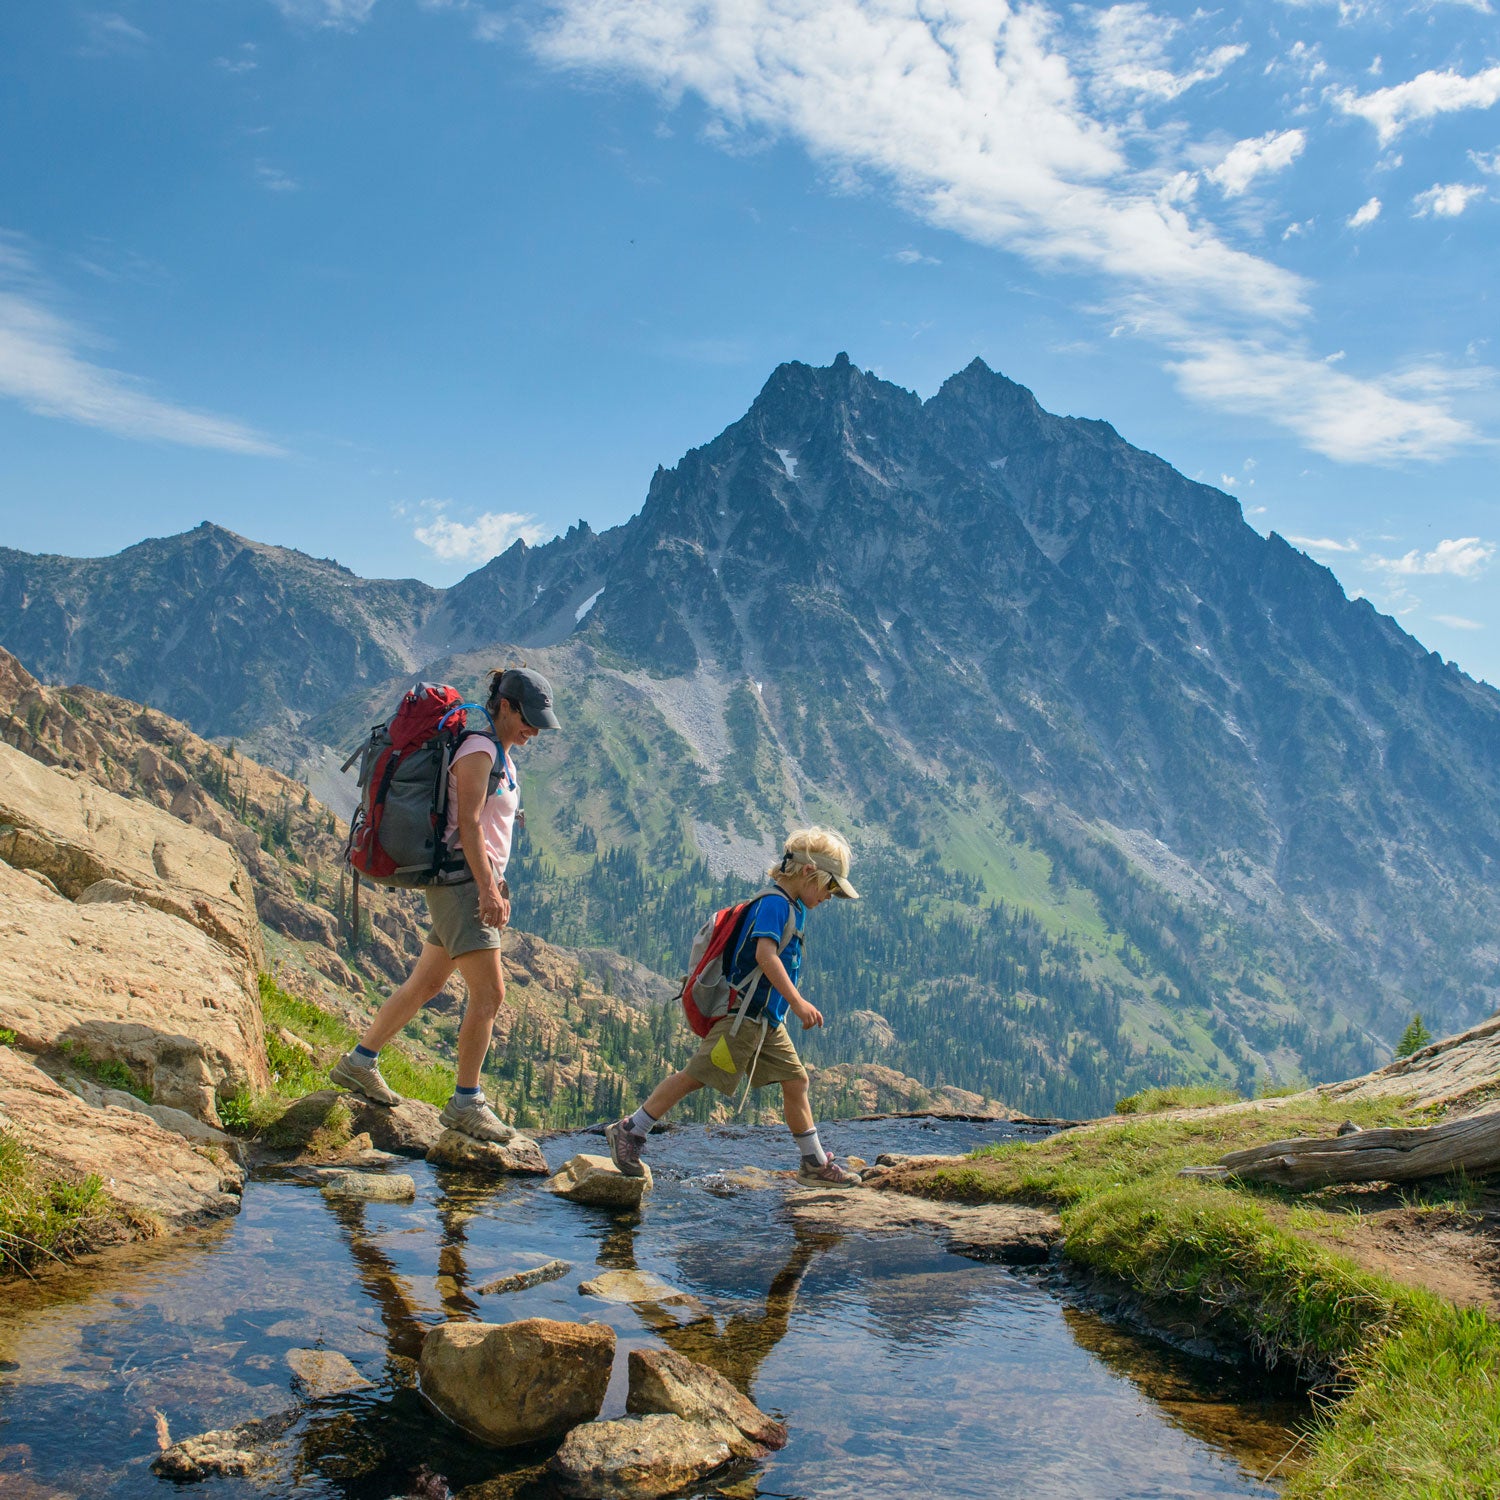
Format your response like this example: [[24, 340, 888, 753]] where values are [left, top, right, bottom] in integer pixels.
[[417, 1317, 615, 1448]]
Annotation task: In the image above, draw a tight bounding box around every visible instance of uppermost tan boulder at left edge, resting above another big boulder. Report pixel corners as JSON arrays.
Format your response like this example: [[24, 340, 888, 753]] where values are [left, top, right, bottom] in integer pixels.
[[0, 743, 266, 978]]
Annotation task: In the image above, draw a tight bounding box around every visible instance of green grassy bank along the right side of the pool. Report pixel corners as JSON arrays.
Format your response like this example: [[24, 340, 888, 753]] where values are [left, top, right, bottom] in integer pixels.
[[911, 1100, 1500, 1500]]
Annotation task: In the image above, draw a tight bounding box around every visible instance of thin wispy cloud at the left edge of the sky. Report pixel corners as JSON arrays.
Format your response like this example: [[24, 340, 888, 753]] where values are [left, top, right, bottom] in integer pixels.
[[0, 236, 282, 455]]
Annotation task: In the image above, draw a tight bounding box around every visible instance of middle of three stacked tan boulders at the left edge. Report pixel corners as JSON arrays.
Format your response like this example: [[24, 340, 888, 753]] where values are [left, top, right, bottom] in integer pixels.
[[0, 858, 270, 1128]]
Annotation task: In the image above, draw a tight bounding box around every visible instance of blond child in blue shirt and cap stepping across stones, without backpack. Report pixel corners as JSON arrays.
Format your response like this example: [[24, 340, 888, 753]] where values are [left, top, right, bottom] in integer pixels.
[[605, 828, 860, 1188]]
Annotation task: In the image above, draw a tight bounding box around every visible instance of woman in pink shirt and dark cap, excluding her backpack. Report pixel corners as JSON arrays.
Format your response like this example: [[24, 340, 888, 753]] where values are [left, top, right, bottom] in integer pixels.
[[329, 668, 558, 1142]]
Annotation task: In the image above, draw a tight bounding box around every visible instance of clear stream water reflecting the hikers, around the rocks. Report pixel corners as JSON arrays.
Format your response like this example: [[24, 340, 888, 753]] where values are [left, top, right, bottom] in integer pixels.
[[0, 1121, 1307, 1500]]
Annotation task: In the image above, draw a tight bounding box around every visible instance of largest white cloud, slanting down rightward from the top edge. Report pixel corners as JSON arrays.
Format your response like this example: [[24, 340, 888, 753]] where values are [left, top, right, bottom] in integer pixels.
[[536, 0, 1304, 327]]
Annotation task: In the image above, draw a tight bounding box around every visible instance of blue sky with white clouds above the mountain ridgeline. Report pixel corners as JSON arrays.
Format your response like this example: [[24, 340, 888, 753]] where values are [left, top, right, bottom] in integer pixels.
[[0, 0, 1500, 683]]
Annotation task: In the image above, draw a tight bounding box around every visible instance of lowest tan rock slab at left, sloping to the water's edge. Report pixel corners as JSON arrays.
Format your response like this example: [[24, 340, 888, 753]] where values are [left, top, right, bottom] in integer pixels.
[[0, 1047, 245, 1239]]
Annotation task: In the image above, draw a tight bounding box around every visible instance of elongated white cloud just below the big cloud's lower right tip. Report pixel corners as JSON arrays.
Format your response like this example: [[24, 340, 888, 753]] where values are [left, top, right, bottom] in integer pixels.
[[1169, 338, 1478, 464]]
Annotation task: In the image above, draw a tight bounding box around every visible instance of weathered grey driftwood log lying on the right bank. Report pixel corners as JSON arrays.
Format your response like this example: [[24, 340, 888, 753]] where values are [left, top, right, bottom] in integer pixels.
[[1209, 1113, 1500, 1188]]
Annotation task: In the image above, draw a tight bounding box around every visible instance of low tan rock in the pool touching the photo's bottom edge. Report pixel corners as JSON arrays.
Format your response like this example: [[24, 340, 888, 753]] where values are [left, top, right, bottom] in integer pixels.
[[548, 1416, 732, 1500]]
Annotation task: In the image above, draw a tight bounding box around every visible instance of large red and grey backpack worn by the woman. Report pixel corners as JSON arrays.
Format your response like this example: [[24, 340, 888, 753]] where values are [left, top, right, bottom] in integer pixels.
[[344, 683, 506, 887]]
